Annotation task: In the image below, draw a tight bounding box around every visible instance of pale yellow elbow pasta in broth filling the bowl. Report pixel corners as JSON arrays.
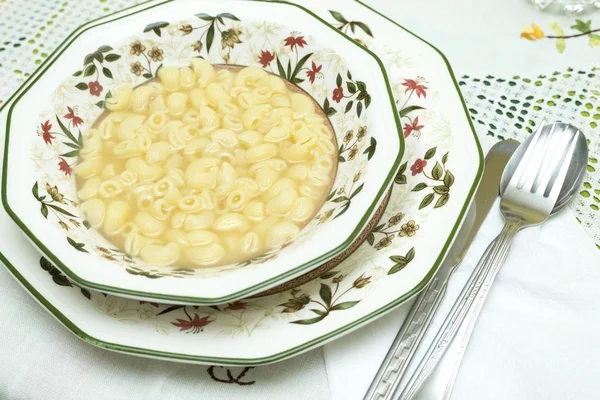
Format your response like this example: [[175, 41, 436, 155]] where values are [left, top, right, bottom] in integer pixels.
[[74, 65, 337, 267]]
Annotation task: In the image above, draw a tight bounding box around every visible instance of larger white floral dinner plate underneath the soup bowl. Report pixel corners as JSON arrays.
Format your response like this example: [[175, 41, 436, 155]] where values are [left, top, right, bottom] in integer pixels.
[[0, 0, 483, 365]]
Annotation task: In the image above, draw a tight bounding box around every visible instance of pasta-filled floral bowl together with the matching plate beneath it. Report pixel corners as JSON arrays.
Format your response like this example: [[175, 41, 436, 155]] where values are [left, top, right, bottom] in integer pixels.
[[0, 0, 483, 365]]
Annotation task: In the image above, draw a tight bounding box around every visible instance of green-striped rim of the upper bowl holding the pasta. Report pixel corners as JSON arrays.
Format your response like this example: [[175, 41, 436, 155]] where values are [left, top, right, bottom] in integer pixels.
[[2, 0, 405, 305]]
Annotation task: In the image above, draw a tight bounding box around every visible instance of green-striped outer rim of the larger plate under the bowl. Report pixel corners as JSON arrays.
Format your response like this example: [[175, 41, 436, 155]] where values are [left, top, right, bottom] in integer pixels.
[[0, 0, 484, 366]]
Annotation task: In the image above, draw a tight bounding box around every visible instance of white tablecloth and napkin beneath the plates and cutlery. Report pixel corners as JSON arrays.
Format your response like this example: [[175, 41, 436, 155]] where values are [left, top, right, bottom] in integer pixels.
[[0, 0, 600, 400]]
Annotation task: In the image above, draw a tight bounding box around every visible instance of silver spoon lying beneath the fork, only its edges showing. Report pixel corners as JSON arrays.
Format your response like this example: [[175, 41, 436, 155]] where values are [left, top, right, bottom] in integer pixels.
[[418, 124, 588, 400]]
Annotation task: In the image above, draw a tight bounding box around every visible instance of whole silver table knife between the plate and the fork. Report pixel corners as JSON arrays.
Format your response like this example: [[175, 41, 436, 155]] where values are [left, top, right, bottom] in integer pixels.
[[364, 140, 519, 400]]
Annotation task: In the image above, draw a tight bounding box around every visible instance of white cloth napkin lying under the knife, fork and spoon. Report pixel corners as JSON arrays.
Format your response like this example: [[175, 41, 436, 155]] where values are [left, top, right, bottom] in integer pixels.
[[325, 205, 600, 400]]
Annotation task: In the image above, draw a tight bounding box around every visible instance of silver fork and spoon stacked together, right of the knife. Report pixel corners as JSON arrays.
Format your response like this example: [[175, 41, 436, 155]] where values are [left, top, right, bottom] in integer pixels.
[[400, 122, 587, 400]]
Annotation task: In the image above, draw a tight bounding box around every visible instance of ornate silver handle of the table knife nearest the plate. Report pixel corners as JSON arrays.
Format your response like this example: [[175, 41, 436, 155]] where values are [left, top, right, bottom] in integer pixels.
[[364, 268, 447, 400]]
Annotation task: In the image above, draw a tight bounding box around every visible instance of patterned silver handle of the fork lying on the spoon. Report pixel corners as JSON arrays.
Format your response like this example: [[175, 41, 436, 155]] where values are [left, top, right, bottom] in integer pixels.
[[400, 219, 522, 400]]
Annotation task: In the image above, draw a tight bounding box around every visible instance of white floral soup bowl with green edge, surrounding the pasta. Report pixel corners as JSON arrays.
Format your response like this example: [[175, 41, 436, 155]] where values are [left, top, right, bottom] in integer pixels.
[[2, 0, 403, 305]]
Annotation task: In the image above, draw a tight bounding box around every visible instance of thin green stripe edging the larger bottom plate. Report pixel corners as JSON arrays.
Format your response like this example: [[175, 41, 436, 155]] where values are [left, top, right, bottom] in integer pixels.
[[0, 0, 483, 365]]
